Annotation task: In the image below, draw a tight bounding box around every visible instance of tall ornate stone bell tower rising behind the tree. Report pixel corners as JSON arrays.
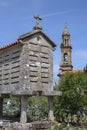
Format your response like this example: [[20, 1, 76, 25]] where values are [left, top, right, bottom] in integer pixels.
[[60, 25, 73, 75]]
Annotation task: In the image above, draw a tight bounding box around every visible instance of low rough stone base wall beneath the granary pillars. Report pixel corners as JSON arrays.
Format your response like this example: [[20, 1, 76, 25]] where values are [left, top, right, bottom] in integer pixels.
[[0, 121, 51, 130]]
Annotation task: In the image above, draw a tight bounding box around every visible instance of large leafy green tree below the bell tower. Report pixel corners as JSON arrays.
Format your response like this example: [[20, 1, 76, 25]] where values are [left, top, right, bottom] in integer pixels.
[[54, 72, 87, 125]]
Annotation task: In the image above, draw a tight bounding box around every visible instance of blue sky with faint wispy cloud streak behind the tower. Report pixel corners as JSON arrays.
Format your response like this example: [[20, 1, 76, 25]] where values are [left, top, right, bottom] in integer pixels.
[[0, 0, 87, 81]]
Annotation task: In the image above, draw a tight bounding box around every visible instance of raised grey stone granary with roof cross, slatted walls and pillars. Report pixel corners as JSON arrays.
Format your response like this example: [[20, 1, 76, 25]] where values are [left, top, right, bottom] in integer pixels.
[[0, 16, 61, 123]]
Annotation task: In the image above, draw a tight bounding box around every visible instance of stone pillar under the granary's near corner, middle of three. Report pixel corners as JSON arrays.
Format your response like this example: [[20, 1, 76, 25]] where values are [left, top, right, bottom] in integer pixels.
[[20, 96, 28, 123]]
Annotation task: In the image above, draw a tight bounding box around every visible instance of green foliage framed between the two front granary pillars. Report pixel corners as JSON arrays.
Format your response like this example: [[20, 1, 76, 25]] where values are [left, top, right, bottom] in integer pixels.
[[27, 96, 48, 121]]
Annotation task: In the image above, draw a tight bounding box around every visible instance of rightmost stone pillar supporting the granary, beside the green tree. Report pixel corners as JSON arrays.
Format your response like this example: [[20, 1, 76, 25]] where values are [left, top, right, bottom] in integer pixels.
[[48, 96, 54, 122]]
